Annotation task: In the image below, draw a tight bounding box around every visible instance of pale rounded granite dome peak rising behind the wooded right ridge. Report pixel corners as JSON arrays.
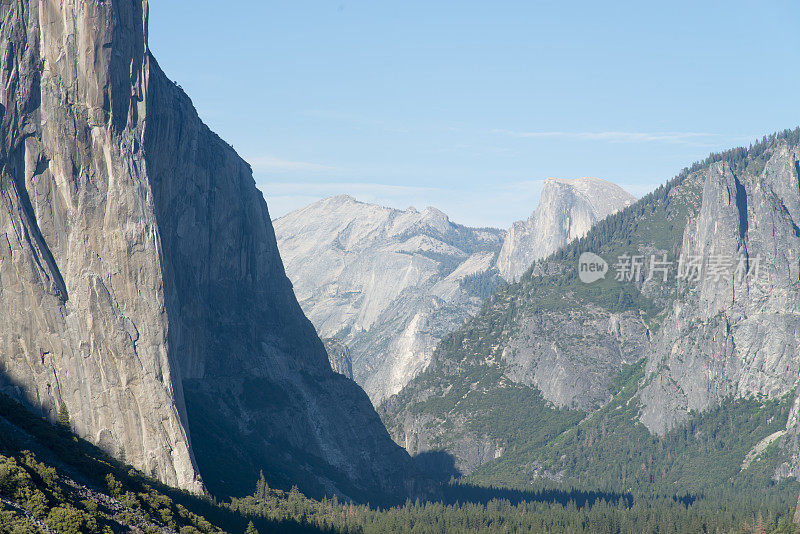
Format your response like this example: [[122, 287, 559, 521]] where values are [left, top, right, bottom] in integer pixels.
[[497, 178, 636, 282]]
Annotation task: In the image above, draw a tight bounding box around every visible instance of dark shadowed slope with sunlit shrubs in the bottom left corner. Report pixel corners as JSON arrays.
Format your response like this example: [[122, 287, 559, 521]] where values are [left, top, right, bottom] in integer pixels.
[[0, 394, 318, 534]]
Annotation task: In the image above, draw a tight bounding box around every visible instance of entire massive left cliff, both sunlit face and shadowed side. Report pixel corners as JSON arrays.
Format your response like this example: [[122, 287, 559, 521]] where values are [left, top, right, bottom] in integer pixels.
[[0, 0, 411, 498]]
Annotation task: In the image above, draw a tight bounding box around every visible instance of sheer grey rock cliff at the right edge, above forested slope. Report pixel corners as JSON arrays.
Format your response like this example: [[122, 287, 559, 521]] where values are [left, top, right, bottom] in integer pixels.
[[641, 144, 800, 433]]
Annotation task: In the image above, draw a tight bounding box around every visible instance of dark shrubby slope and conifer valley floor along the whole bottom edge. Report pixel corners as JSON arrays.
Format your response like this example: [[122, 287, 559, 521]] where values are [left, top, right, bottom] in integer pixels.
[[0, 395, 800, 534]]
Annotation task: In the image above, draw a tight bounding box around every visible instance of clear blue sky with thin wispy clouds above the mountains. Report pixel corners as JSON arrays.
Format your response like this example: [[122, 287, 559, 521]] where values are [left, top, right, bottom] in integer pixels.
[[150, 0, 800, 227]]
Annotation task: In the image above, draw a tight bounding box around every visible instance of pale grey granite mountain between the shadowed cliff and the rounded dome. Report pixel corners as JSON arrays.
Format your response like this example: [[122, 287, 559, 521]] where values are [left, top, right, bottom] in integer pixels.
[[275, 196, 503, 405]]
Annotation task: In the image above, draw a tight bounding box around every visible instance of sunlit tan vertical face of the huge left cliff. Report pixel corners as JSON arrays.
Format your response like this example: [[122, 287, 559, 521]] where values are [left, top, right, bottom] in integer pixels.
[[0, 1, 201, 491]]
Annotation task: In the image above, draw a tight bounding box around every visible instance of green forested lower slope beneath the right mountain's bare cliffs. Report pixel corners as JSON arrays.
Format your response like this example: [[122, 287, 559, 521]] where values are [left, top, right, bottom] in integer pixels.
[[469, 362, 800, 504]]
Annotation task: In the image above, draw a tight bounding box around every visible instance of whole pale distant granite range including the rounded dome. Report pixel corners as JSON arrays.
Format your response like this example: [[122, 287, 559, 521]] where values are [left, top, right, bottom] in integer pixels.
[[274, 178, 633, 405]]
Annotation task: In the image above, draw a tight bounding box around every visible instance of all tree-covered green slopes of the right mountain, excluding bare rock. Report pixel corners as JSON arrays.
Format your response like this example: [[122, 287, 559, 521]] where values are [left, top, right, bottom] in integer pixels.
[[379, 128, 800, 524]]
